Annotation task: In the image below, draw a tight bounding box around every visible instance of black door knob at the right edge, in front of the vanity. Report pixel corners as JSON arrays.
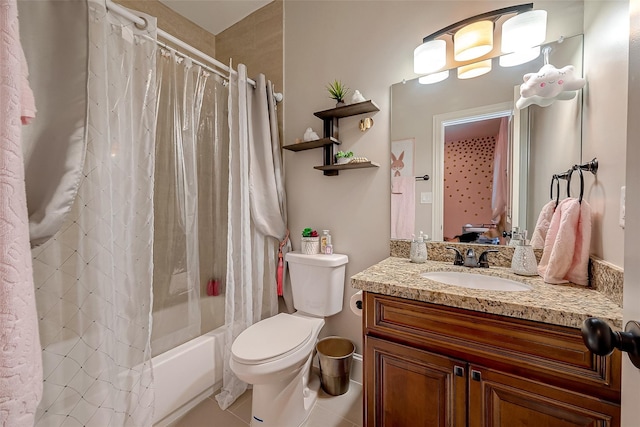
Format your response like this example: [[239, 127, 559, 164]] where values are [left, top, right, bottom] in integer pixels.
[[581, 317, 640, 369]]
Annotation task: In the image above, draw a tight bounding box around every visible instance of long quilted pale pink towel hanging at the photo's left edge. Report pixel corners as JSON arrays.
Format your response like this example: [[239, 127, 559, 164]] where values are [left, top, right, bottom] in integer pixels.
[[0, 0, 42, 427]]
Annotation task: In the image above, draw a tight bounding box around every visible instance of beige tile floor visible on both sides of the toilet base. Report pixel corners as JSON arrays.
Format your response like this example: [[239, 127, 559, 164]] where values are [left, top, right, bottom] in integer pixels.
[[172, 382, 362, 427]]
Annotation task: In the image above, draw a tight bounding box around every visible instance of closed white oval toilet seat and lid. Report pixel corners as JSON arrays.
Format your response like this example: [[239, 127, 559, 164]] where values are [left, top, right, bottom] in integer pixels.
[[231, 313, 314, 365]]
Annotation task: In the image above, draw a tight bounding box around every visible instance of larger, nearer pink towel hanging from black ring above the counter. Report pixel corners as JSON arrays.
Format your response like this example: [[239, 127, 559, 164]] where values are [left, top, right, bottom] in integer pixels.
[[538, 198, 591, 285]]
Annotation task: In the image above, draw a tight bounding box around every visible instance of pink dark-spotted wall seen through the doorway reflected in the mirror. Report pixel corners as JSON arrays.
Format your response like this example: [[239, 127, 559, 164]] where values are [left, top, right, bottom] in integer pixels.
[[443, 136, 496, 239]]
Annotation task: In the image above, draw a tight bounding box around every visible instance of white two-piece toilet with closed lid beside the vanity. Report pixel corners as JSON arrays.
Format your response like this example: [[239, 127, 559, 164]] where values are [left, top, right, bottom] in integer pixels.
[[229, 252, 349, 427]]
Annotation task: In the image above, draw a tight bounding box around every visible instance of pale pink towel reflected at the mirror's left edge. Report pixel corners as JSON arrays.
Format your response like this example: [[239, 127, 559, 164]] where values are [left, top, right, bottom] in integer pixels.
[[391, 176, 416, 239]]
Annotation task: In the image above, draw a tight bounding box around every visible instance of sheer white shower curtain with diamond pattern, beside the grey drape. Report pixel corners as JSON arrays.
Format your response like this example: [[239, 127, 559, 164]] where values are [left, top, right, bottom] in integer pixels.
[[33, 1, 156, 427]]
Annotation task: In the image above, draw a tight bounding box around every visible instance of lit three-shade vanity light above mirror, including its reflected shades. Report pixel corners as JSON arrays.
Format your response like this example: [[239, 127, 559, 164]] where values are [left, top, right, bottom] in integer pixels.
[[413, 3, 547, 79]]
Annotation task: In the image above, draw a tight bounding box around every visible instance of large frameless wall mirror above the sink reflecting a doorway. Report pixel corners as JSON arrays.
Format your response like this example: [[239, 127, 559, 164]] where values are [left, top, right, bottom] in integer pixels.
[[391, 35, 583, 244]]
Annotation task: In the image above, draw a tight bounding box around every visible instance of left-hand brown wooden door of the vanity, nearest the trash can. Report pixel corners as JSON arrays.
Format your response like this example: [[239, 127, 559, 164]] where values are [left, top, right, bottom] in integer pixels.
[[364, 336, 466, 427]]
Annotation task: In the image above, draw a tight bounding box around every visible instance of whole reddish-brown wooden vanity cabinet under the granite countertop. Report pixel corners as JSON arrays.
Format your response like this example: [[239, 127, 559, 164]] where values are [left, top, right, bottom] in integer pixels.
[[363, 292, 620, 427]]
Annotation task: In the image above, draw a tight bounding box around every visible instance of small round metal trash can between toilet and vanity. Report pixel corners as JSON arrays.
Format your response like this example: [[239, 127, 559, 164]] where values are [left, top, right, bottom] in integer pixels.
[[316, 337, 356, 396]]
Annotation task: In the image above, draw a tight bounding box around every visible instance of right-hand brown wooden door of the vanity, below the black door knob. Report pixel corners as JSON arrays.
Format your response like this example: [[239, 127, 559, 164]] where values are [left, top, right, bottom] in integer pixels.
[[469, 365, 620, 427]]
